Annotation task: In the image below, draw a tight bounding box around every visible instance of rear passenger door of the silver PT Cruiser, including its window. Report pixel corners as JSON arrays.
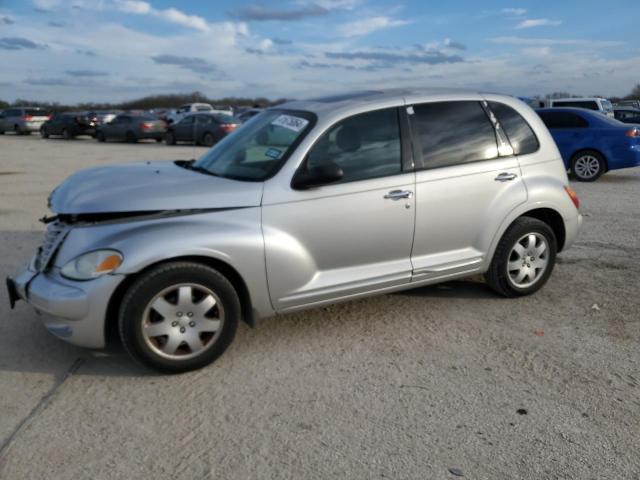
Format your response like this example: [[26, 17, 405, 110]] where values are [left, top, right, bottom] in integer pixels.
[[408, 100, 537, 280]]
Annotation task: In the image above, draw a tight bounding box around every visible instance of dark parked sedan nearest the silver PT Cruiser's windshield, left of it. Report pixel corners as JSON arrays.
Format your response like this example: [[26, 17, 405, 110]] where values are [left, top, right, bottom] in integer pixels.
[[165, 113, 241, 147]]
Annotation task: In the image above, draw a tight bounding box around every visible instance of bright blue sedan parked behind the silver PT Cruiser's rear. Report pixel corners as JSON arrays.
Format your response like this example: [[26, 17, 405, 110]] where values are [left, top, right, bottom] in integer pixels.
[[538, 108, 640, 182]]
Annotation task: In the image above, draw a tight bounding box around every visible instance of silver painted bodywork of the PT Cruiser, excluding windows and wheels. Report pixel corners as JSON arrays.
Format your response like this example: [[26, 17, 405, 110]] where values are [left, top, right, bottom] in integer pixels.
[[10, 90, 581, 346]]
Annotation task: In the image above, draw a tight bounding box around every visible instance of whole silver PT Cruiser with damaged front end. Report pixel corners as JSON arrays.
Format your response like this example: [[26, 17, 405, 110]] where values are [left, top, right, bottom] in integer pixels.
[[7, 90, 581, 372]]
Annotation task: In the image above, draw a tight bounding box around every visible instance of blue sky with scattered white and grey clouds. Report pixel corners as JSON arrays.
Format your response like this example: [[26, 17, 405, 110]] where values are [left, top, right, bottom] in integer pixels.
[[0, 0, 640, 103]]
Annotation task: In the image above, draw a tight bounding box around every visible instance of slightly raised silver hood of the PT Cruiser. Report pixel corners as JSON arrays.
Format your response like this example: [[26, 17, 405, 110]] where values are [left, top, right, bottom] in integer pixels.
[[49, 161, 262, 214]]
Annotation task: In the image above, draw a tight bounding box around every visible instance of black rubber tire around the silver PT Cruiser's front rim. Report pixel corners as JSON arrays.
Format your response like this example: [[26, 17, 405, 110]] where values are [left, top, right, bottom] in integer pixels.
[[118, 262, 241, 373]]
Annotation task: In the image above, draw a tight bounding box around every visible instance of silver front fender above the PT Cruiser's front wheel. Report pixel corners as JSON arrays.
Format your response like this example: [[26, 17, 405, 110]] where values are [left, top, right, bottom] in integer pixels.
[[55, 207, 273, 317]]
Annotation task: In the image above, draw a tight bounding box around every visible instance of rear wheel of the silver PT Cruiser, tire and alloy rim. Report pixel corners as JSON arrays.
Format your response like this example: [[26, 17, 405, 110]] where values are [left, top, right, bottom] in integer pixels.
[[485, 217, 558, 297]]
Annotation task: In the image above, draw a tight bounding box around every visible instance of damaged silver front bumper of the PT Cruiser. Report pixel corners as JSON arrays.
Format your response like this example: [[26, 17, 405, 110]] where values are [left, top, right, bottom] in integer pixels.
[[7, 268, 124, 348]]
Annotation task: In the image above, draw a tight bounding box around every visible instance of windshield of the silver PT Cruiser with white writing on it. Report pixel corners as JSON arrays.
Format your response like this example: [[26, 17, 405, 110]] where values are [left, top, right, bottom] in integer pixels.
[[194, 110, 315, 181]]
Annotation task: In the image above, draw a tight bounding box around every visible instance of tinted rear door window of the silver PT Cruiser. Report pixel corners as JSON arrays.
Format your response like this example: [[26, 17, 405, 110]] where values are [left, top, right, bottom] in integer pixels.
[[410, 101, 498, 169]]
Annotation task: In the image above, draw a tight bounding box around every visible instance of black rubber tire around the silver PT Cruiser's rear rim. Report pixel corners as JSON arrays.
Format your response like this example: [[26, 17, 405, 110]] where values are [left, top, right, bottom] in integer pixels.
[[484, 217, 558, 297]]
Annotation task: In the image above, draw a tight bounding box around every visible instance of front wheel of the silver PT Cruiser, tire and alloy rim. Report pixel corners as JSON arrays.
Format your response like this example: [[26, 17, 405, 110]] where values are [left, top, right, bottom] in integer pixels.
[[119, 262, 241, 373]]
